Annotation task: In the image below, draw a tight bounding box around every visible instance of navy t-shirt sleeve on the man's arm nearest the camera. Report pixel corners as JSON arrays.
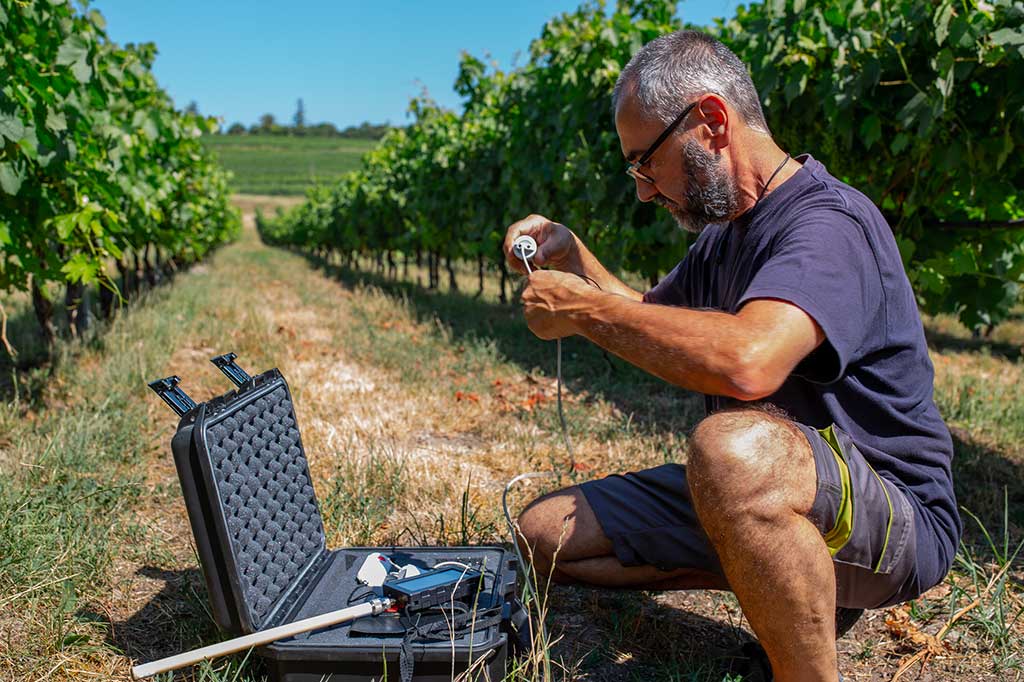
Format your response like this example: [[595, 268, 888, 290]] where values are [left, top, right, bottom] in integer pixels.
[[737, 211, 885, 384]]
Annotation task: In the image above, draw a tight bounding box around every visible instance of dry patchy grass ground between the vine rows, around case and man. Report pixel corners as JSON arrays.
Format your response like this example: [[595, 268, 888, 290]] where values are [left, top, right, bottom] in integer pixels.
[[0, 199, 1024, 682]]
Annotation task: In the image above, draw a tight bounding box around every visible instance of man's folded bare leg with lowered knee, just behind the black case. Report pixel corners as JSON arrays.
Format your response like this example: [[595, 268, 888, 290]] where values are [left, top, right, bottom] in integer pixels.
[[518, 487, 728, 590]]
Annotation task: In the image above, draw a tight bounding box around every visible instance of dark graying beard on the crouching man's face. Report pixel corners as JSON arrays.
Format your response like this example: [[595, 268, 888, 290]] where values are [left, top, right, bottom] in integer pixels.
[[654, 139, 739, 235]]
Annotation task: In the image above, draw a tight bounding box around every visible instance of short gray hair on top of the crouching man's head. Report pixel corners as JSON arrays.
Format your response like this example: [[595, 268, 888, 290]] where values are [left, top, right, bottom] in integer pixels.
[[611, 31, 771, 135]]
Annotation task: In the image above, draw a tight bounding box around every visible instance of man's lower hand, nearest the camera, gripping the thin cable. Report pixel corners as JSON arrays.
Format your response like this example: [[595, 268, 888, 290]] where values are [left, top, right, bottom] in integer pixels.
[[520, 266, 600, 341]]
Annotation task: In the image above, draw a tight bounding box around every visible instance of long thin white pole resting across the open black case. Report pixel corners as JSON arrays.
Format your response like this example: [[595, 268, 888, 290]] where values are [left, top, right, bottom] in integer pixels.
[[131, 598, 394, 680]]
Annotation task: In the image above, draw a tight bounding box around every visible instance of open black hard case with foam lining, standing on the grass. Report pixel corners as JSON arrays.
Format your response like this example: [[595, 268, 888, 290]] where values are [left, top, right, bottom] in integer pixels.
[[171, 370, 516, 682]]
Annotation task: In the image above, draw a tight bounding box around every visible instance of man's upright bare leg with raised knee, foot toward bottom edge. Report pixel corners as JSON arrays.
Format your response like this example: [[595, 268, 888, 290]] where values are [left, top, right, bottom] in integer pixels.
[[687, 411, 837, 682]]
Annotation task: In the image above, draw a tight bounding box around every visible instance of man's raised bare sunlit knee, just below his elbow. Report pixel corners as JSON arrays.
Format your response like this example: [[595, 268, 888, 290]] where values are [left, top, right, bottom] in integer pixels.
[[687, 410, 816, 522]]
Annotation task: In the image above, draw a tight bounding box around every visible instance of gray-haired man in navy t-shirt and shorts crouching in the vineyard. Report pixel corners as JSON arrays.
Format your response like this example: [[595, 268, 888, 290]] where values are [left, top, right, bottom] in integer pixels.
[[505, 31, 962, 681]]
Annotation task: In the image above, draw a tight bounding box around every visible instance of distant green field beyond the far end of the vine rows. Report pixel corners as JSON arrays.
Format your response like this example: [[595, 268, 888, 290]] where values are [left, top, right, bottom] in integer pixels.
[[203, 135, 377, 195]]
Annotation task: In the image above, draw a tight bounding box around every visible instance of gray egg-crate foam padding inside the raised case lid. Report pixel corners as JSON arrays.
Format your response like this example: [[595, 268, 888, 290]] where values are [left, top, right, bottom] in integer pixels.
[[207, 385, 325, 628]]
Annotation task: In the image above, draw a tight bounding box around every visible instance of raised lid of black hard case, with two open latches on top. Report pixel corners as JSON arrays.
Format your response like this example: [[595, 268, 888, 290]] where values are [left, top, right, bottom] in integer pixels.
[[151, 353, 327, 634]]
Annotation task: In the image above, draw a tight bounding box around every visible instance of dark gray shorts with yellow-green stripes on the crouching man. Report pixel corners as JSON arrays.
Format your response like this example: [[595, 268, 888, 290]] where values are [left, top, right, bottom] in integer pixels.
[[580, 424, 921, 608]]
